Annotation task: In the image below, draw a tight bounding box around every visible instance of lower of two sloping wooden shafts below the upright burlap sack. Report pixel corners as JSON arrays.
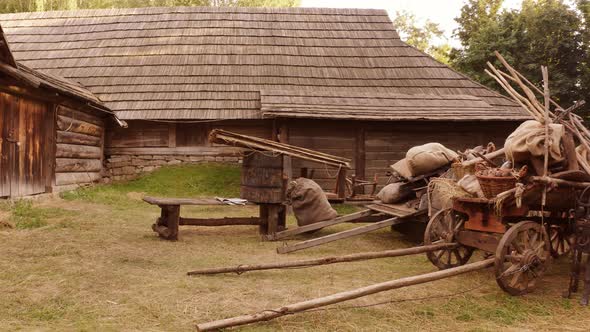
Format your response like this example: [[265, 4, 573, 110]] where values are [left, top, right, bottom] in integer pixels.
[[277, 212, 423, 254]]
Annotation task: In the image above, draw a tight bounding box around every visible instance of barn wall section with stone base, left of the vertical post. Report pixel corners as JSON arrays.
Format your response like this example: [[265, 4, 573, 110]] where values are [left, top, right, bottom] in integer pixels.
[[105, 120, 272, 180]]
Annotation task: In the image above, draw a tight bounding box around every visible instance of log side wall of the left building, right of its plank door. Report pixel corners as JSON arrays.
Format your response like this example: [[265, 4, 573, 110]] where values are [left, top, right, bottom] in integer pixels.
[[55, 106, 105, 186]]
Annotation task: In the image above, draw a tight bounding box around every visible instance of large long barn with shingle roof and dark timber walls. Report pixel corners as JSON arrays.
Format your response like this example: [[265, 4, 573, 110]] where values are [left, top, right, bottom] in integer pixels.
[[0, 7, 528, 190]]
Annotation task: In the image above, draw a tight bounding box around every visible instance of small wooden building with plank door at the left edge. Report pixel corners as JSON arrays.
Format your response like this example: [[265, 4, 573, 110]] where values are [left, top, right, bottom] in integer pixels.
[[0, 28, 120, 197]]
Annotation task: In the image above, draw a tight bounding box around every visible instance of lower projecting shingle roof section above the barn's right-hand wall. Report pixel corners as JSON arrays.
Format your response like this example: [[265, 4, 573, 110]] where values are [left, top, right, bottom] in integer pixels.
[[260, 90, 522, 121]]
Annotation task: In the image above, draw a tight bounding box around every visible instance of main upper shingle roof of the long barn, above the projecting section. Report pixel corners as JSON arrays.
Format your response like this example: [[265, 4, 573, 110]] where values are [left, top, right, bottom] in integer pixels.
[[0, 7, 526, 120]]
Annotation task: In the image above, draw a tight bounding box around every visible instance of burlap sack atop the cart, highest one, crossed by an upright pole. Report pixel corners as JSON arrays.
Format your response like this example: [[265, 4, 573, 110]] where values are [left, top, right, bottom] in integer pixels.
[[504, 120, 564, 164]]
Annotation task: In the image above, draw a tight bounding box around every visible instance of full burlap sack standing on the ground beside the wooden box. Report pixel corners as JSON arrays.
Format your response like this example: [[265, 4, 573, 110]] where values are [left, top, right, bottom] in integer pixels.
[[287, 178, 338, 226]]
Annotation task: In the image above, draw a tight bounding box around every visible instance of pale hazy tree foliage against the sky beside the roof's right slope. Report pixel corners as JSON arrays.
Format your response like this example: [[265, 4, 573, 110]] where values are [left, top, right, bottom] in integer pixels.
[[393, 11, 451, 64]]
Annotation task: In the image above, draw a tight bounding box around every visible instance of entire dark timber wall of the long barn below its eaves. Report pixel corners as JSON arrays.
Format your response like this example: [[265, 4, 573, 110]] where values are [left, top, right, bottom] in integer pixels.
[[103, 116, 518, 191]]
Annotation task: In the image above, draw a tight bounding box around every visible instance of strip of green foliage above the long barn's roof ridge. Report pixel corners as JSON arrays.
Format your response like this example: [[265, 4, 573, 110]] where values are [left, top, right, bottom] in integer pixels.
[[0, 0, 300, 13]]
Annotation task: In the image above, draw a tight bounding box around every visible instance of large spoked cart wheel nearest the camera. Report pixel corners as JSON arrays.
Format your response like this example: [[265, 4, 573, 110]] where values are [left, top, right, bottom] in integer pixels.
[[495, 220, 551, 296]]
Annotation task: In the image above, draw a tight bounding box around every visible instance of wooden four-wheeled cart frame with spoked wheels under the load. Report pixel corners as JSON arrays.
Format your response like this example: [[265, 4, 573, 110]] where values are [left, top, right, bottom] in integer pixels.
[[424, 176, 578, 295]]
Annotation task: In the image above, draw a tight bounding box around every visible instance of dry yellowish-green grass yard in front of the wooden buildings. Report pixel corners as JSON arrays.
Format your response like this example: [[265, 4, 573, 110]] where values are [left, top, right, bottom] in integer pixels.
[[0, 165, 590, 331]]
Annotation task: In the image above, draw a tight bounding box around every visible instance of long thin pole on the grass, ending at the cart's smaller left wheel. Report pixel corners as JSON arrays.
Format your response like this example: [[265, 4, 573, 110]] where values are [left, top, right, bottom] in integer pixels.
[[187, 243, 458, 275]]
